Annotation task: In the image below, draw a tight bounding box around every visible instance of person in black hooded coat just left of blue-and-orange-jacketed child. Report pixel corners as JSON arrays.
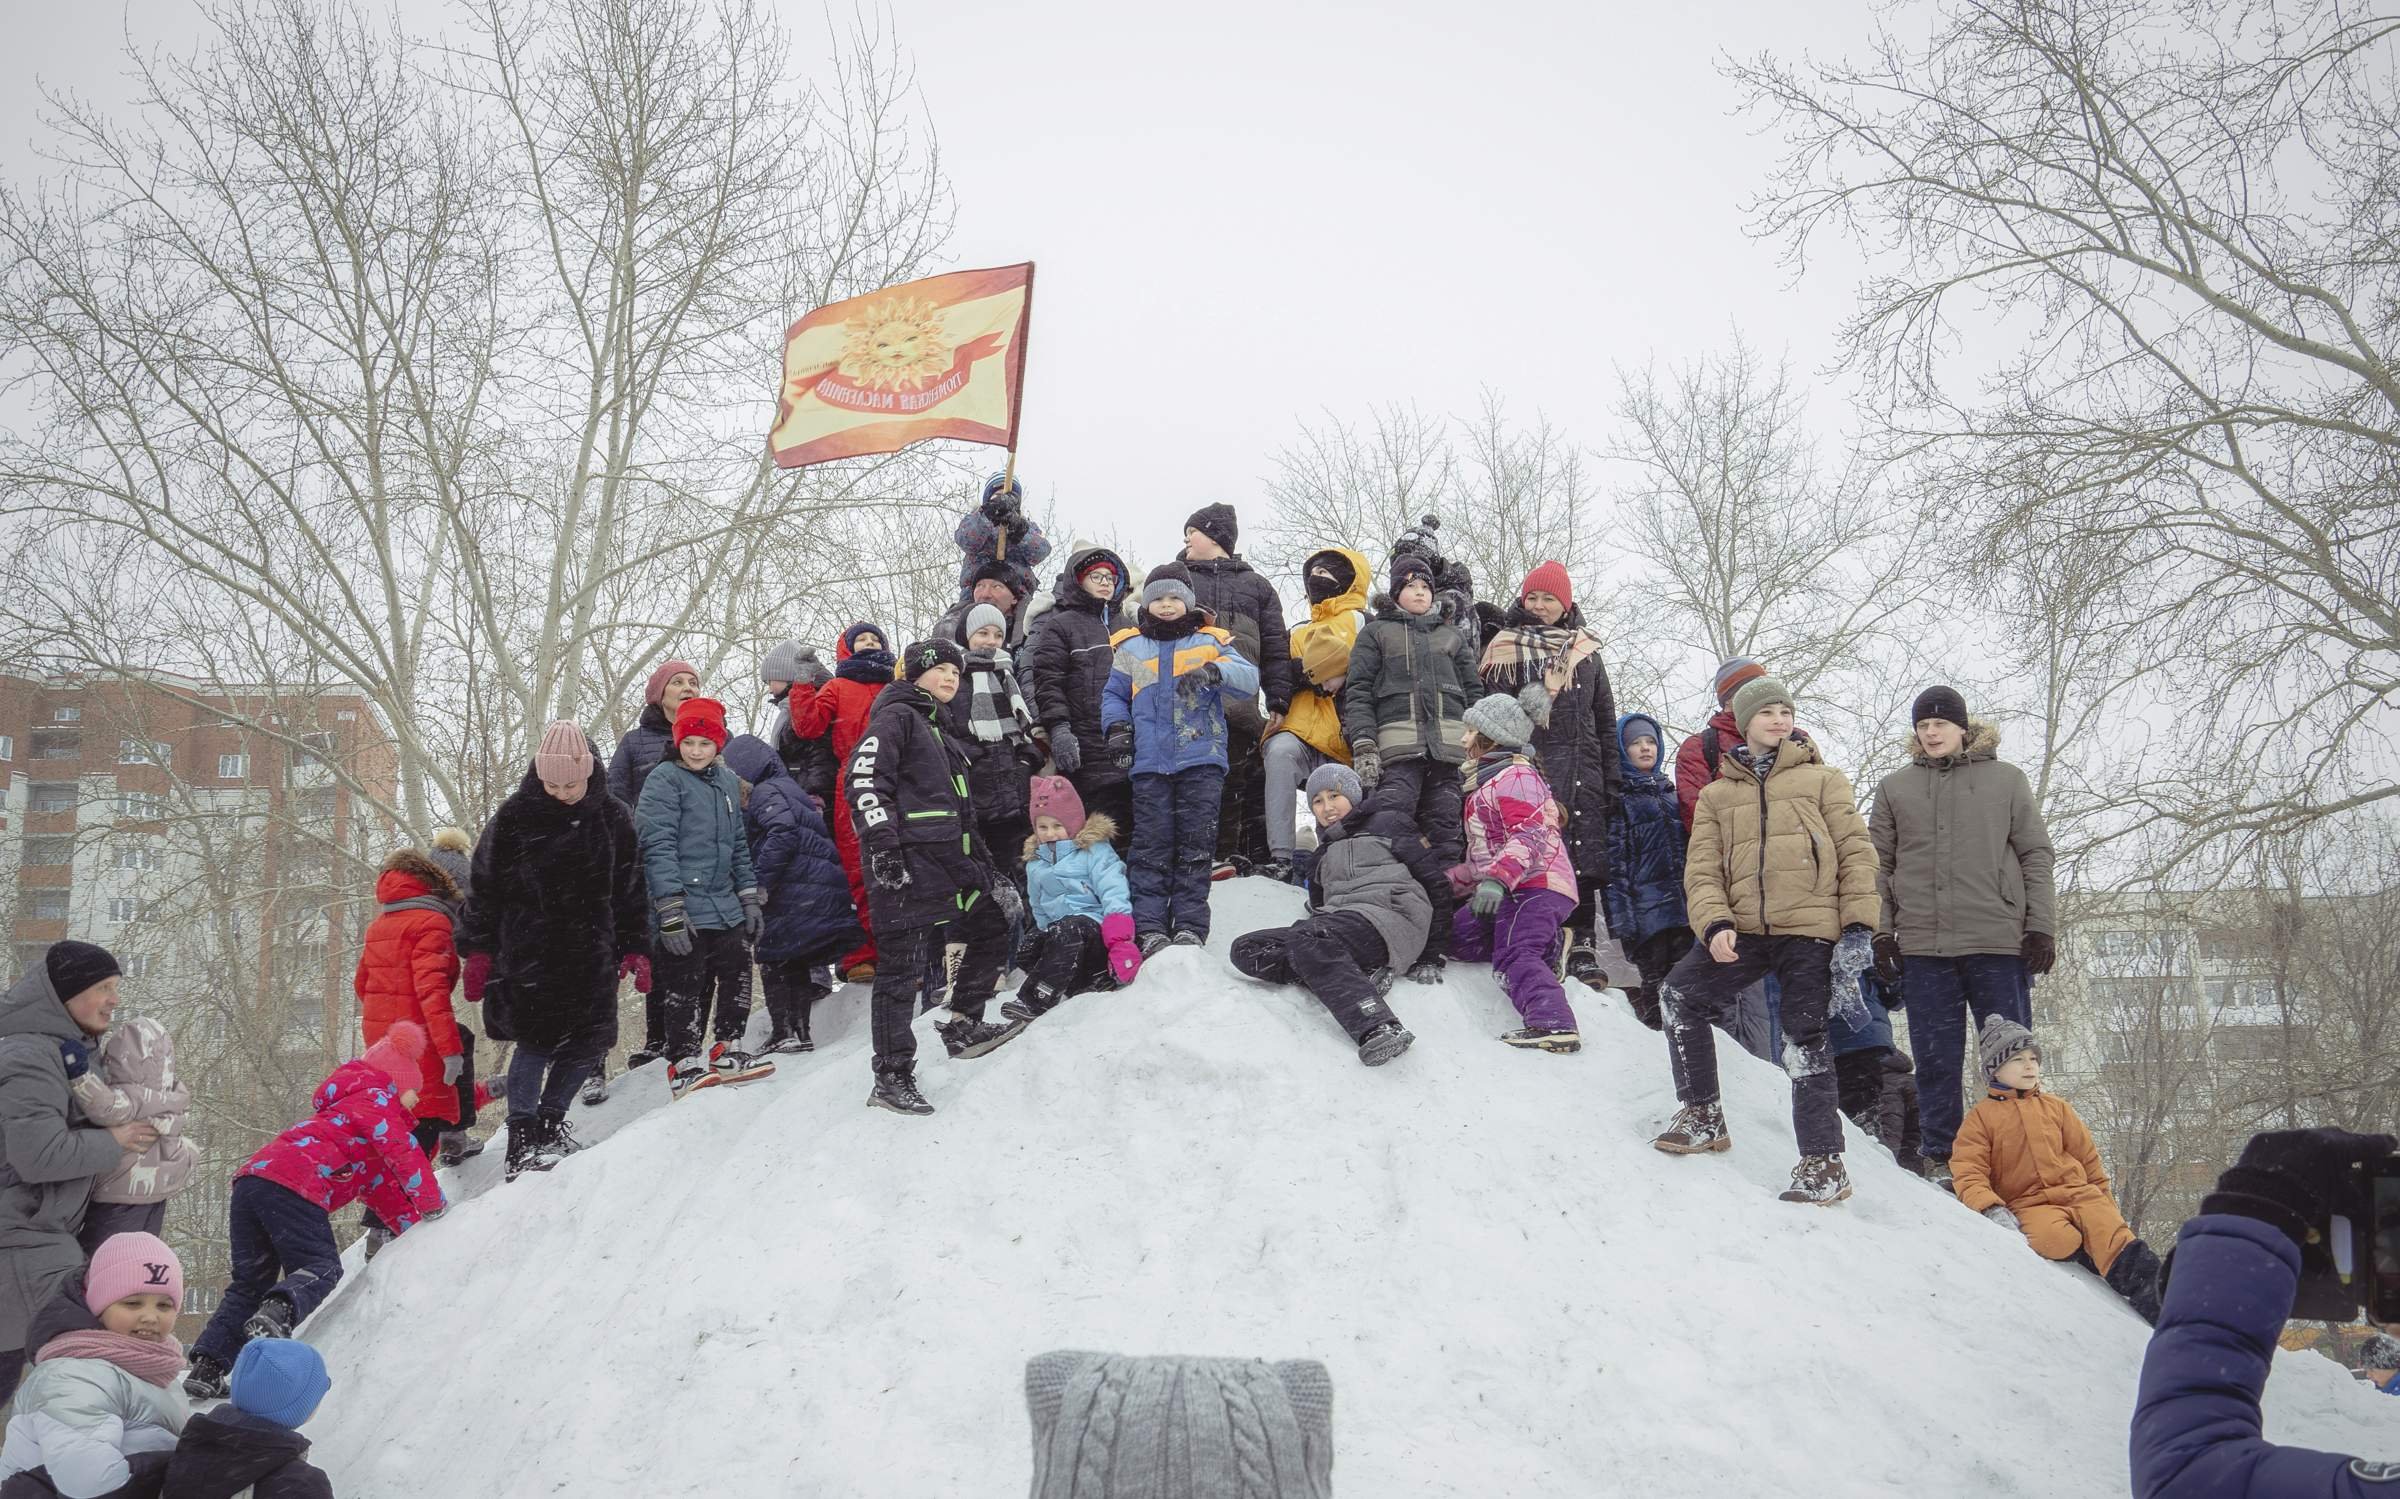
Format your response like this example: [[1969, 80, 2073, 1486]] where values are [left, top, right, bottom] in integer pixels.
[[1025, 547, 1133, 854]]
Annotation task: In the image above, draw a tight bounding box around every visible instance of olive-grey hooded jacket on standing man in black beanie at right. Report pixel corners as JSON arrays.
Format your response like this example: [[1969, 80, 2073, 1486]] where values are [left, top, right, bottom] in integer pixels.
[[1867, 720, 2059, 957]]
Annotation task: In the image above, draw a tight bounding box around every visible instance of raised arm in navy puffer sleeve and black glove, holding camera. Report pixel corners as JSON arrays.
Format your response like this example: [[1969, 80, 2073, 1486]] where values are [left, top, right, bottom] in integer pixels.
[[2131, 1130, 2400, 1499]]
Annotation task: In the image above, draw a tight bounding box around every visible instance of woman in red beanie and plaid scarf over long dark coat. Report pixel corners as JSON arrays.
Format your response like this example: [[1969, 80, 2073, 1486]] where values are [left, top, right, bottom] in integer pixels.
[[1478, 561, 1622, 983]]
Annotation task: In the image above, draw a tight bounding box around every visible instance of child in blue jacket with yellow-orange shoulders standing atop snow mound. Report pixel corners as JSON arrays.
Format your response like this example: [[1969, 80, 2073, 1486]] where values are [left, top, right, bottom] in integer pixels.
[[1099, 561, 1258, 957]]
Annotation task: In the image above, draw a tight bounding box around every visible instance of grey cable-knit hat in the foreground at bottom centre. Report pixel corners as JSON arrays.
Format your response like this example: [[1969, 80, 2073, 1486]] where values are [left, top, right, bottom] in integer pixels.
[[1025, 1353, 1334, 1499]]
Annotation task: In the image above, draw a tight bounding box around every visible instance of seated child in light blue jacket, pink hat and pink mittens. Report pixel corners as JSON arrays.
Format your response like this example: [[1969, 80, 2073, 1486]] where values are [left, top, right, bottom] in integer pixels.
[[1001, 775, 1142, 1019]]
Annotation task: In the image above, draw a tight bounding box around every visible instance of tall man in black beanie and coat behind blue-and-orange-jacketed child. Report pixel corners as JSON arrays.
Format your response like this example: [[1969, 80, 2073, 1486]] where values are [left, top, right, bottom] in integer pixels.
[[1183, 504, 1291, 863]]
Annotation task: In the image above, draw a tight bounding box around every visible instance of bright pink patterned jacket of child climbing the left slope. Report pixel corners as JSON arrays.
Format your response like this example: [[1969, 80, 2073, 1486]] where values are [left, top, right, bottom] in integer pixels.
[[240, 1062, 442, 1233]]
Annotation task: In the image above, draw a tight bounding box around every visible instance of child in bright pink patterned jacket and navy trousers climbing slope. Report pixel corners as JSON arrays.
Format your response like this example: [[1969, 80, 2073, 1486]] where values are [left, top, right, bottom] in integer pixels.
[[185, 1019, 446, 1398]]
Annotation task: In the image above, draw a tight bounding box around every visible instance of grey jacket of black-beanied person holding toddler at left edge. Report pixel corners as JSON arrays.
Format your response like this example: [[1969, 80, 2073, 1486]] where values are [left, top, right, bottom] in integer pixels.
[[0, 962, 125, 1350]]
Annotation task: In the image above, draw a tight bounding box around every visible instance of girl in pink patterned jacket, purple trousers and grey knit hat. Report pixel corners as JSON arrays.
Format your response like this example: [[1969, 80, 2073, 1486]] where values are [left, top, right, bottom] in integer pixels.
[[1450, 693, 1584, 1053]]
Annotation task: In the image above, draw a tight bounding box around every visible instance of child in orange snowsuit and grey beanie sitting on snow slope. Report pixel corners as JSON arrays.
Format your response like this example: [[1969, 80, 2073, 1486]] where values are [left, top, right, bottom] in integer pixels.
[[1951, 1015, 2160, 1324]]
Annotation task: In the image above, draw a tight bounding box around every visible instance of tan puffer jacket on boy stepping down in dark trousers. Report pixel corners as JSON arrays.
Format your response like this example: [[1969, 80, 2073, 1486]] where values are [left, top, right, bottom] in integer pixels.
[[1682, 734, 1879, 943]]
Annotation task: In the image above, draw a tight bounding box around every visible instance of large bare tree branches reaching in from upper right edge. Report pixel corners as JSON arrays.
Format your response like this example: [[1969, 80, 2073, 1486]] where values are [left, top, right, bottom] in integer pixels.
[[1728, 0, 2400, 871]]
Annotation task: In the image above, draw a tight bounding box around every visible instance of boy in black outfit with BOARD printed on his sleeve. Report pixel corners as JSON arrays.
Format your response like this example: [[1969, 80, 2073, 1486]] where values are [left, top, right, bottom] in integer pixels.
[[842, 640, 1025, 1113]]
